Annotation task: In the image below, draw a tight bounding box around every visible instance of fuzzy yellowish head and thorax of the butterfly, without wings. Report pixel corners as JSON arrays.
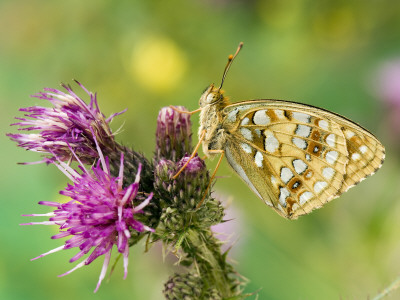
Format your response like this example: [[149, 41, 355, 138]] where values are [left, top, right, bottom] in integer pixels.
[[198, 84, 229, 157]]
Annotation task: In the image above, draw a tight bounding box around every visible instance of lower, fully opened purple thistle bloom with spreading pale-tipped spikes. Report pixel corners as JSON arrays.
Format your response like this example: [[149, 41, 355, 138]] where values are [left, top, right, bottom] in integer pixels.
[[21, 143, 154, 292]]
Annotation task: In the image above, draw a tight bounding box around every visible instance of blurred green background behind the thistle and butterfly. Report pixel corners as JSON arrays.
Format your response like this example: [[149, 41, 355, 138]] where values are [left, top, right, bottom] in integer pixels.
[[0, 0, 400, 300]]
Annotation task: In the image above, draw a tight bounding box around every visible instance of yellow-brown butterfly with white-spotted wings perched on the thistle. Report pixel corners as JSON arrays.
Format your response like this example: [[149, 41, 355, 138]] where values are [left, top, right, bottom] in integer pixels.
[[174, 43, 385, 219]]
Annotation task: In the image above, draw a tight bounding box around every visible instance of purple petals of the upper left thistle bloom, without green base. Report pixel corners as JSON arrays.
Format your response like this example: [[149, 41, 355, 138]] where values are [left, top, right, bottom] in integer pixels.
[[7, 81, 125, 163]]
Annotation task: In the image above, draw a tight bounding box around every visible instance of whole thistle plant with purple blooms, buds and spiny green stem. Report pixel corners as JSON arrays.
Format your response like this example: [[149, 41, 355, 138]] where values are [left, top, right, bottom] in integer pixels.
[[8, 83, 246, 299]]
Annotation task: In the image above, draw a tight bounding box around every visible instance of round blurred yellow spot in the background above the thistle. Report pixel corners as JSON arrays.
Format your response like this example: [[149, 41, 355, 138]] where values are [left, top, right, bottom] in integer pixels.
[[131, 37, 187, 92]]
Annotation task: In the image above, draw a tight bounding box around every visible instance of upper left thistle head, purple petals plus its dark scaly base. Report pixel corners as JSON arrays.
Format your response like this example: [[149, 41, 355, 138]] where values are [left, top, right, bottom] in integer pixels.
[[7, 81, 153, 192]]
